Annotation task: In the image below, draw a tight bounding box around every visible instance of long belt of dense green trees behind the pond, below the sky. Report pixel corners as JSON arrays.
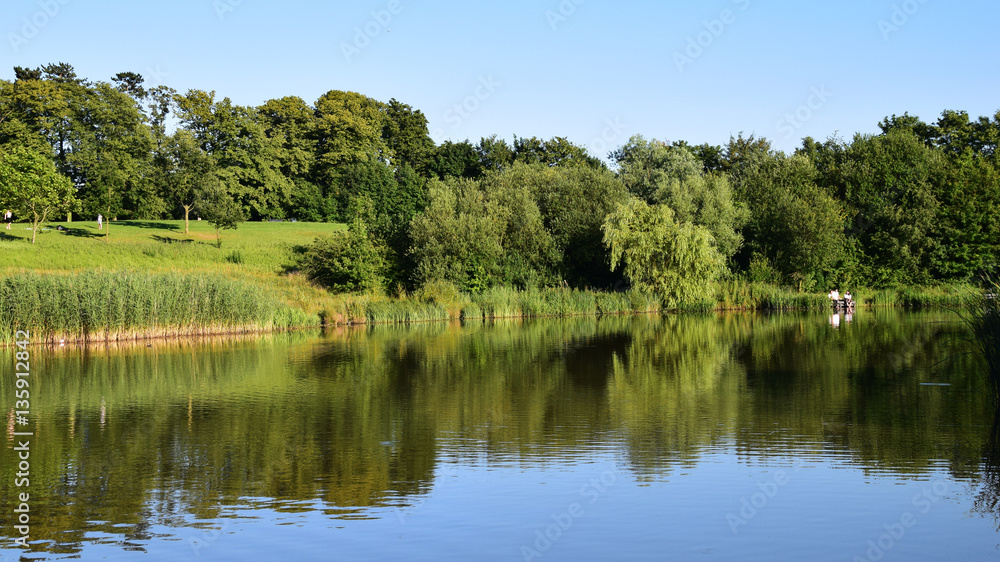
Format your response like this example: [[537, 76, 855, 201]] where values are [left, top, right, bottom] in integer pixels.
[[0, 63, 1000, 294]]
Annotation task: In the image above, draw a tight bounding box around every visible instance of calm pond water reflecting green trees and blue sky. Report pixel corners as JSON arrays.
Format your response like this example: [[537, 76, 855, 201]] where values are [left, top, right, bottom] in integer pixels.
[[0, 311, 1000, 561]]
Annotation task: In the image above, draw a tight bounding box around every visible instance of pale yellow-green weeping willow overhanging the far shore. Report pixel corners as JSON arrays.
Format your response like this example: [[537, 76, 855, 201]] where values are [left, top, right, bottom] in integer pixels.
[[601, 199, 722, 306]]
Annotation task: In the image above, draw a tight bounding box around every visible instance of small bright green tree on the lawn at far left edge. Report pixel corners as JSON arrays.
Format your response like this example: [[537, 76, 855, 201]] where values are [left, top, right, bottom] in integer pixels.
[[0, 145, 76, 244]]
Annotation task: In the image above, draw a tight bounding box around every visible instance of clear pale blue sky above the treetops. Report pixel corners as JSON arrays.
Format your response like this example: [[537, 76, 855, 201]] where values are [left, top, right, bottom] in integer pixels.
[[0, 0, 1000, 156]]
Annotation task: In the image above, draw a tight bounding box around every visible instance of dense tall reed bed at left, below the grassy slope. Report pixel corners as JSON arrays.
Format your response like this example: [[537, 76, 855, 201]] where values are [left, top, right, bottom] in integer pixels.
[[0, 271, 318, 344]]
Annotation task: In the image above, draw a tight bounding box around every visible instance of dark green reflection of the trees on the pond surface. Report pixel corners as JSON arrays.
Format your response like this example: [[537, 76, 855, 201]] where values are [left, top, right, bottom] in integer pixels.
[[0, 312, 1000, 553]]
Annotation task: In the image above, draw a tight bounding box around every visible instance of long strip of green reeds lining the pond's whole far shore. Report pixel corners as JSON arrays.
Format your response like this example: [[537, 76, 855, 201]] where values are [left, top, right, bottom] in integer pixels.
[[0, 271, 974, 345]]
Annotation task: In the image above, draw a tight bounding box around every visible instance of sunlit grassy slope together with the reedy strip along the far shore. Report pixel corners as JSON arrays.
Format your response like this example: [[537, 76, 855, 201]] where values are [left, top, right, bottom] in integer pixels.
[[0, 221, 974, 342]]
